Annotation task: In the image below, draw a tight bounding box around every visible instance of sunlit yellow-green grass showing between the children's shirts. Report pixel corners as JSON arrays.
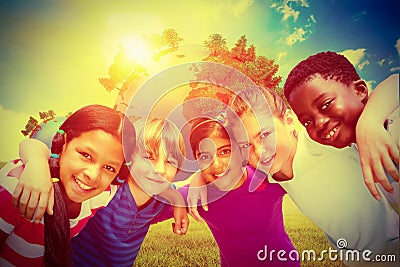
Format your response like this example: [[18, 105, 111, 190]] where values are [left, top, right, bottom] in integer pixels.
[[134, 196, 340, 267]]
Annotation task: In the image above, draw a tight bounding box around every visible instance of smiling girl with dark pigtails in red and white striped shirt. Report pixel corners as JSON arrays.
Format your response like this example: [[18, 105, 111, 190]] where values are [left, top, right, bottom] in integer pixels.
[[0, 105, 135, 266]]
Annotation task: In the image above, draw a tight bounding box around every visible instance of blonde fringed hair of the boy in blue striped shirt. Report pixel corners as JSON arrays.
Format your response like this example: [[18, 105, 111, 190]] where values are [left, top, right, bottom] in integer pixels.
[[135, 117, 186, 169]]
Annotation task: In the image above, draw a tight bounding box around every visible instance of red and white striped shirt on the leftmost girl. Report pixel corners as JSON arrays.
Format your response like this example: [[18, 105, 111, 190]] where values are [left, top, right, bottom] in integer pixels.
[[0, 160, 117, 266]]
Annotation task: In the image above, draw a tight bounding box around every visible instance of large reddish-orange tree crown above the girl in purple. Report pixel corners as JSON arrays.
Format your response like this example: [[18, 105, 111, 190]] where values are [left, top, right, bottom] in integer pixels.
[[184, 33, 285, 117]]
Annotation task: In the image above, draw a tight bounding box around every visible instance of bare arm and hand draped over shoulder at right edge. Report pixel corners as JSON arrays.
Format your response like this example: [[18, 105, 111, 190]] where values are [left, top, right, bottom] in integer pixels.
[[356, 74, 399, 200]]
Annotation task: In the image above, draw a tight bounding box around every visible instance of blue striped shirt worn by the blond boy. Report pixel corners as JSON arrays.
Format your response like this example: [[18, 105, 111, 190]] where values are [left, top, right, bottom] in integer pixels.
[[72, 183, 167, 267]]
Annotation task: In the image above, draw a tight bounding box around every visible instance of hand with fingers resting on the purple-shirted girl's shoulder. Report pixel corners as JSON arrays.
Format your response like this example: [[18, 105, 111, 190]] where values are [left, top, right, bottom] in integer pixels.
[[187, 171, 208, 222]]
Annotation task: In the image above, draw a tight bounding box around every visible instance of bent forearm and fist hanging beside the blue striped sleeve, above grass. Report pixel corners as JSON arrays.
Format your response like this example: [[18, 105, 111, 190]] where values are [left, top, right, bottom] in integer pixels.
[[159, 187, 189, 235]]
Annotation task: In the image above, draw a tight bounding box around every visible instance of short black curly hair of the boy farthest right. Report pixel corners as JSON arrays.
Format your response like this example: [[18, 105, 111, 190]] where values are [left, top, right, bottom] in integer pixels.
[[283, 51, 360, 100]]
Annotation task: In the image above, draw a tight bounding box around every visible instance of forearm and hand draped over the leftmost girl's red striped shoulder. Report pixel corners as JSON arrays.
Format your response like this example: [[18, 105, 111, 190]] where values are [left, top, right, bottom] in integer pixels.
[[12, 139, 54, 222]]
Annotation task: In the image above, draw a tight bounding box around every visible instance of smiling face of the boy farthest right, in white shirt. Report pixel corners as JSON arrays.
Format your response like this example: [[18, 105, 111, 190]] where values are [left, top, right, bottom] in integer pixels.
[[288, 75, 368, 148]]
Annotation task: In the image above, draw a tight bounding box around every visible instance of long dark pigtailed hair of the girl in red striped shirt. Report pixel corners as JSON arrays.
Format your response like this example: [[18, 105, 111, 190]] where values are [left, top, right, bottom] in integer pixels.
[[44, 105, 136, 266]]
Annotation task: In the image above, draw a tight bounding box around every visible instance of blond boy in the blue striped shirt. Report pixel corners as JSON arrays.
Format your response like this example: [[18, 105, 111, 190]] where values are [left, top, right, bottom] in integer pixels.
[[10, 117, 189, 266]]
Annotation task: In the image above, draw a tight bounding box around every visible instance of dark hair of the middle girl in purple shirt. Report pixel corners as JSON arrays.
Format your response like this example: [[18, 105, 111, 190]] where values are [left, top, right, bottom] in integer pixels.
[[189, 117, 232, 159]]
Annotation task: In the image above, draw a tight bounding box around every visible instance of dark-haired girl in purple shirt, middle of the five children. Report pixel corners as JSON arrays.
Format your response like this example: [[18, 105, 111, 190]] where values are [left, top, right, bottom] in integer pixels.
[[186, 118, 300, 266]]
